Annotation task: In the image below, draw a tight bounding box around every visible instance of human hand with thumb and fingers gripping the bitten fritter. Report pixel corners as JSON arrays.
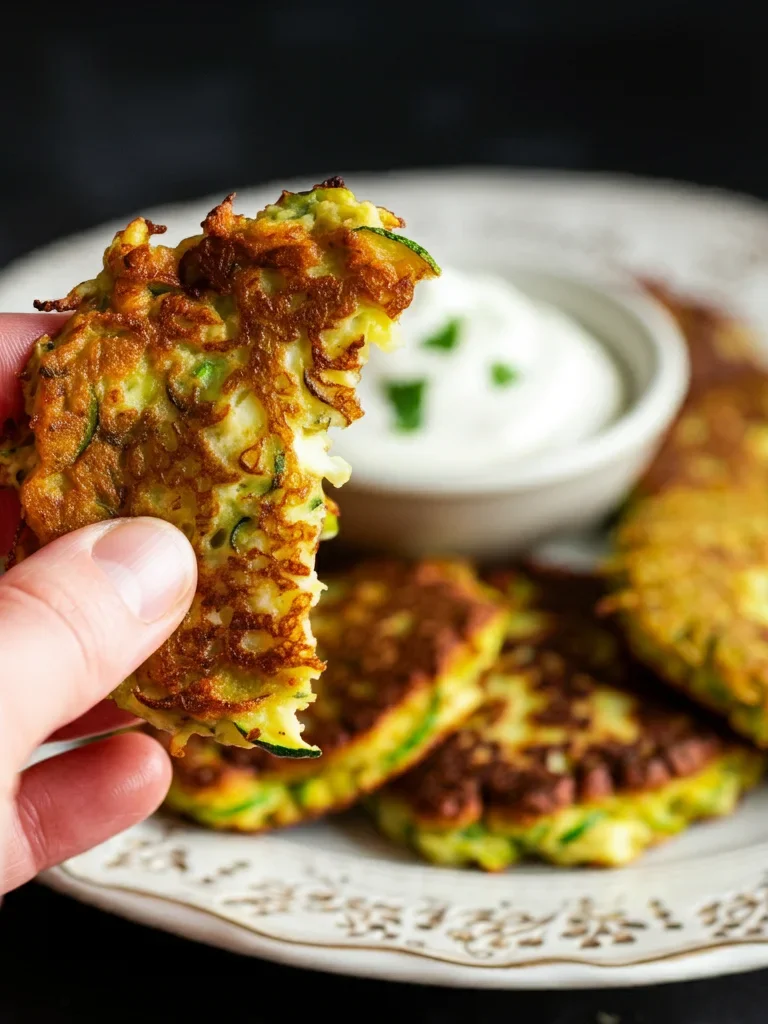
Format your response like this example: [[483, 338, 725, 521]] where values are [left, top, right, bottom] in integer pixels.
[[0, 314, 197, 892]]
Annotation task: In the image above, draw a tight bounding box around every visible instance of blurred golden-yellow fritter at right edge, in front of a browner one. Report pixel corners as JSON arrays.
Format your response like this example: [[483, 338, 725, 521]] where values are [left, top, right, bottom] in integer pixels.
[[602, 487, 768, 746]]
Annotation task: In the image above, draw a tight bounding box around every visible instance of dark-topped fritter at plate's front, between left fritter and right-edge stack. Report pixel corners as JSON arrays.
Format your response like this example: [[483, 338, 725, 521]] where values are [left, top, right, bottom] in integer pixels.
[[371, 572, 763, 870]]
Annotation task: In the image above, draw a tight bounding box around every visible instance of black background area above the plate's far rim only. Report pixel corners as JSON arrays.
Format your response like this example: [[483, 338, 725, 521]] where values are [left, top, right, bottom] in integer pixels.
[[0, 0, 768, 265]]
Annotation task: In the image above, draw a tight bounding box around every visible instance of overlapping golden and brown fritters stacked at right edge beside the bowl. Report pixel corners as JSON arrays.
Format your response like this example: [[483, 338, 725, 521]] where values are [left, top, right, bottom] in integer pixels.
[[603, 284, 768, 746]]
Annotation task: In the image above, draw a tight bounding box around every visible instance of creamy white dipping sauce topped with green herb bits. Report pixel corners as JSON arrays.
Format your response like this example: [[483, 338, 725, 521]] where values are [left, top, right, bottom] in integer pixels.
[[334, 269, 625, 481]]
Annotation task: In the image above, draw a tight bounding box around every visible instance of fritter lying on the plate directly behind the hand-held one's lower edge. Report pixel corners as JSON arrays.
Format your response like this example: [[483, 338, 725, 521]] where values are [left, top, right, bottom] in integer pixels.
[[162, 561, 507, 831]]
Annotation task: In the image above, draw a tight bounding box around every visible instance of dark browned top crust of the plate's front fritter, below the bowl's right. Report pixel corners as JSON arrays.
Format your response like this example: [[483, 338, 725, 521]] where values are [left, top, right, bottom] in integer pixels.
[[393, 569, 733, 827]]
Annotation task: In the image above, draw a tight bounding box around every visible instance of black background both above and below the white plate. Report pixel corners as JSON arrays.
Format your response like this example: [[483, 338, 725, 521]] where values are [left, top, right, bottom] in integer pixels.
[[0, 0, 768, 1024]]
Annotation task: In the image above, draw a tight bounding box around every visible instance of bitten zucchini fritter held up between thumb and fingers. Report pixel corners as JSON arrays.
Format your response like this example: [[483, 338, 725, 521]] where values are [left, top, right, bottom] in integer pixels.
[[0, 179, 439, 757]]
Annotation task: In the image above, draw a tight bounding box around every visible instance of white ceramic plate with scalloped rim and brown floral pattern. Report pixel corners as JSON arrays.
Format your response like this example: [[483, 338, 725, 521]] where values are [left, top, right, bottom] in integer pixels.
[[0, 171, 768, 988]]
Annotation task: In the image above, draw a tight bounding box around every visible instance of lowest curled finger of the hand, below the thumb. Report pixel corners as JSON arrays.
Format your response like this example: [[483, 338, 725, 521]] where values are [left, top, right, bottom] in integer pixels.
[[0, 732, 171, 892]]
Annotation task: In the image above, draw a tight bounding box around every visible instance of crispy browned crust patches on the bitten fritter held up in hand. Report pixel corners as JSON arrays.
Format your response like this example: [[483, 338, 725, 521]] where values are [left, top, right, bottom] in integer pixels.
[[4, 188, 434, 738]]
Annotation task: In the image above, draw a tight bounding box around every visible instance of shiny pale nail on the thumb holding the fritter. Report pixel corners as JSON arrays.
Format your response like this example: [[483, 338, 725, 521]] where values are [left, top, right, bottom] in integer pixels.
[[91, 518, 195, 623]]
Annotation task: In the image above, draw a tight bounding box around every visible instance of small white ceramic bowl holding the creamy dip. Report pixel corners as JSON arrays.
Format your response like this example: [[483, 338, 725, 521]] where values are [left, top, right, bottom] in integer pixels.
[[331, 269, 689, 558]]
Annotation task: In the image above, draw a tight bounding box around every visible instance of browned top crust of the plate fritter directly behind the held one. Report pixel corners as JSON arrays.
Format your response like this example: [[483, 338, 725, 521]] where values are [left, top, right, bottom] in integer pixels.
[[169, 559, 500, 788]]
